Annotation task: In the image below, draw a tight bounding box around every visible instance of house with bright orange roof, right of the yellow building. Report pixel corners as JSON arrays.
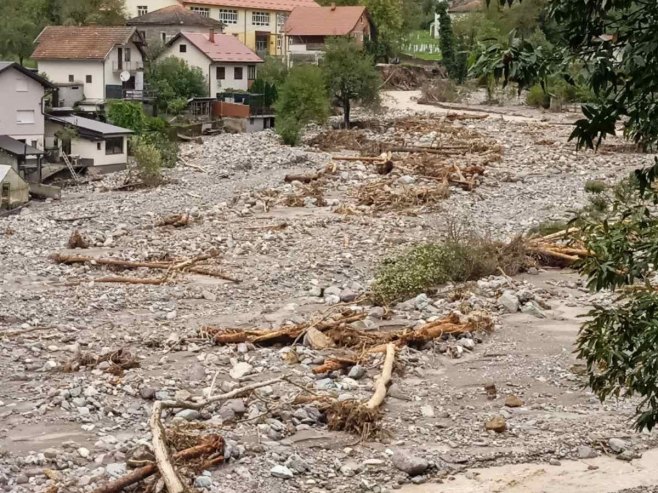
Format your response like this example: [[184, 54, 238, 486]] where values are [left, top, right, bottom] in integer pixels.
[[284, 5, 375, 58]]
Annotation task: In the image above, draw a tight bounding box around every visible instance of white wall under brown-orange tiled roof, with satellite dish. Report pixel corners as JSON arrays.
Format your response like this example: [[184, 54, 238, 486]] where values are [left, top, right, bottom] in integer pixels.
[[37, 60, 105, 99]]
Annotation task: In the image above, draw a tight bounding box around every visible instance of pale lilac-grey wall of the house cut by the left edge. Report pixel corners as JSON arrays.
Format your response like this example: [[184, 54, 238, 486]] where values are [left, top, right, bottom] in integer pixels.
[[0, 68, 45, 149]]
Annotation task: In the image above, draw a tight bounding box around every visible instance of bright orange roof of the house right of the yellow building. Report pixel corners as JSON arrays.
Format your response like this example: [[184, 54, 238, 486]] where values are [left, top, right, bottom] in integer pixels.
[[284, 6, 366, 36]]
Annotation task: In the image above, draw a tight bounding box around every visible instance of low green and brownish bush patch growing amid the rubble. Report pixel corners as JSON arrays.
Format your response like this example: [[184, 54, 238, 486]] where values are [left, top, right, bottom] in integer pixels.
[[371, 236, 529, 305]]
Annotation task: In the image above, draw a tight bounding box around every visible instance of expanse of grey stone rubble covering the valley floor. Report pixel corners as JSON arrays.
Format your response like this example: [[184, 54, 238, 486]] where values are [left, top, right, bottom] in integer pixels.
[[0, 99, 652, 493]]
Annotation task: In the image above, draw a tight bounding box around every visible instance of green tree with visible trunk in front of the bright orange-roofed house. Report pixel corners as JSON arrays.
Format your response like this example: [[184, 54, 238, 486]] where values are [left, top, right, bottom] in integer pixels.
[[322, 38, 381, 128]]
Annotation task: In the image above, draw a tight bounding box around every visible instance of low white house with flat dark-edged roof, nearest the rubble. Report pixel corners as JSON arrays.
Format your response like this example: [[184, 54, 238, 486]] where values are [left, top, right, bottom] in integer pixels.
[[46, 115, 133, 173]]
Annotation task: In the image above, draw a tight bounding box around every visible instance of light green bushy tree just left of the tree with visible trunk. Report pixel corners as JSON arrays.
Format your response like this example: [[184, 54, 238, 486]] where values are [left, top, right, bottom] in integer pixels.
[[274, 65, 329, 145]]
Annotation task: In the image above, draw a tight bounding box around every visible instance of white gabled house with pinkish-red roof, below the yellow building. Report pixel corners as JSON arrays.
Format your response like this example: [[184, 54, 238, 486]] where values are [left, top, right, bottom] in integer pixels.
[[161, 30, 263, 97]]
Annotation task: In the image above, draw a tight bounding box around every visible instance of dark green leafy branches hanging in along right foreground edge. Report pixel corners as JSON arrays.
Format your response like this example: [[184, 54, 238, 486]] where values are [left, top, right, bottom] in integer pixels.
[[492, 0, 658, 429]]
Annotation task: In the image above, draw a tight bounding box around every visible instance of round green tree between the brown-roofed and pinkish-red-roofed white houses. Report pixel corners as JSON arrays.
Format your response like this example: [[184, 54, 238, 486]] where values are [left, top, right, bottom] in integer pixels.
[[147, 56, 208, 113]]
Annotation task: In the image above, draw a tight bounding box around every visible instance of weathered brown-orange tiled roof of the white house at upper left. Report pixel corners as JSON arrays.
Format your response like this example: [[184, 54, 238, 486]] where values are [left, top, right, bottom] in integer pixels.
[[32, 26, 135, 60]]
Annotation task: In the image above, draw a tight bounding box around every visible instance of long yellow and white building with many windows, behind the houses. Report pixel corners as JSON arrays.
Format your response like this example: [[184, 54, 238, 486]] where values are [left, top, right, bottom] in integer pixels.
[[126, 0, 318, 57]]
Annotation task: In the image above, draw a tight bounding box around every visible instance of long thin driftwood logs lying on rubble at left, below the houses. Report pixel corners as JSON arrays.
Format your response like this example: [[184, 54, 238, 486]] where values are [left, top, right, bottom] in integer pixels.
[[50, 252, 240, 285]]
